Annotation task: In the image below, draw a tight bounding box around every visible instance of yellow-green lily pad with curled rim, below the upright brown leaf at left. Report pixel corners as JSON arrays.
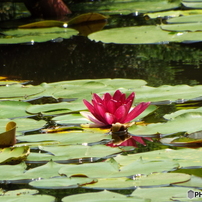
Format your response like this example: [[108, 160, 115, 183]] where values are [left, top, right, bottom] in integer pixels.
[[0, 146, 30, 164]]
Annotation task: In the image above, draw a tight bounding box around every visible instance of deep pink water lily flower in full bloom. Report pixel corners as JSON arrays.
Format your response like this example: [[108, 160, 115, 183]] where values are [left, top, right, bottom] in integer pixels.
[[80, 90, 150, 127]]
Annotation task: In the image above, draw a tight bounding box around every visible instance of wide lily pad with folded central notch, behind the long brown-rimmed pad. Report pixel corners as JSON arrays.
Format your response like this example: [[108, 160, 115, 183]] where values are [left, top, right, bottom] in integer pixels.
[[59, 159, 177, 178]]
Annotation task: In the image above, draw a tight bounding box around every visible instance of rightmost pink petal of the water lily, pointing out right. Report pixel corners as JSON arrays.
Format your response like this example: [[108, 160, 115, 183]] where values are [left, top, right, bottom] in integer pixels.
[[124, 102, 150, 123]]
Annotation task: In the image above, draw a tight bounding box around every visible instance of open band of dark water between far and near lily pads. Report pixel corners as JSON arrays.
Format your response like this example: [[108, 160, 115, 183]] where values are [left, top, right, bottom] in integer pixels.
[[0, 36, 202, 86]]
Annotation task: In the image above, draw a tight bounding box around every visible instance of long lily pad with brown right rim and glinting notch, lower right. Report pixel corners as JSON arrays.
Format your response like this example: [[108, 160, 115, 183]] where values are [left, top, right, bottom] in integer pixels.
[[84, 173, 191, 190]]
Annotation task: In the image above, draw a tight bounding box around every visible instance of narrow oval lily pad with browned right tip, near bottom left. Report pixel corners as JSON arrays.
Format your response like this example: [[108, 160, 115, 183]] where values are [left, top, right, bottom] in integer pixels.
[[29, 177, 97, 189]]
